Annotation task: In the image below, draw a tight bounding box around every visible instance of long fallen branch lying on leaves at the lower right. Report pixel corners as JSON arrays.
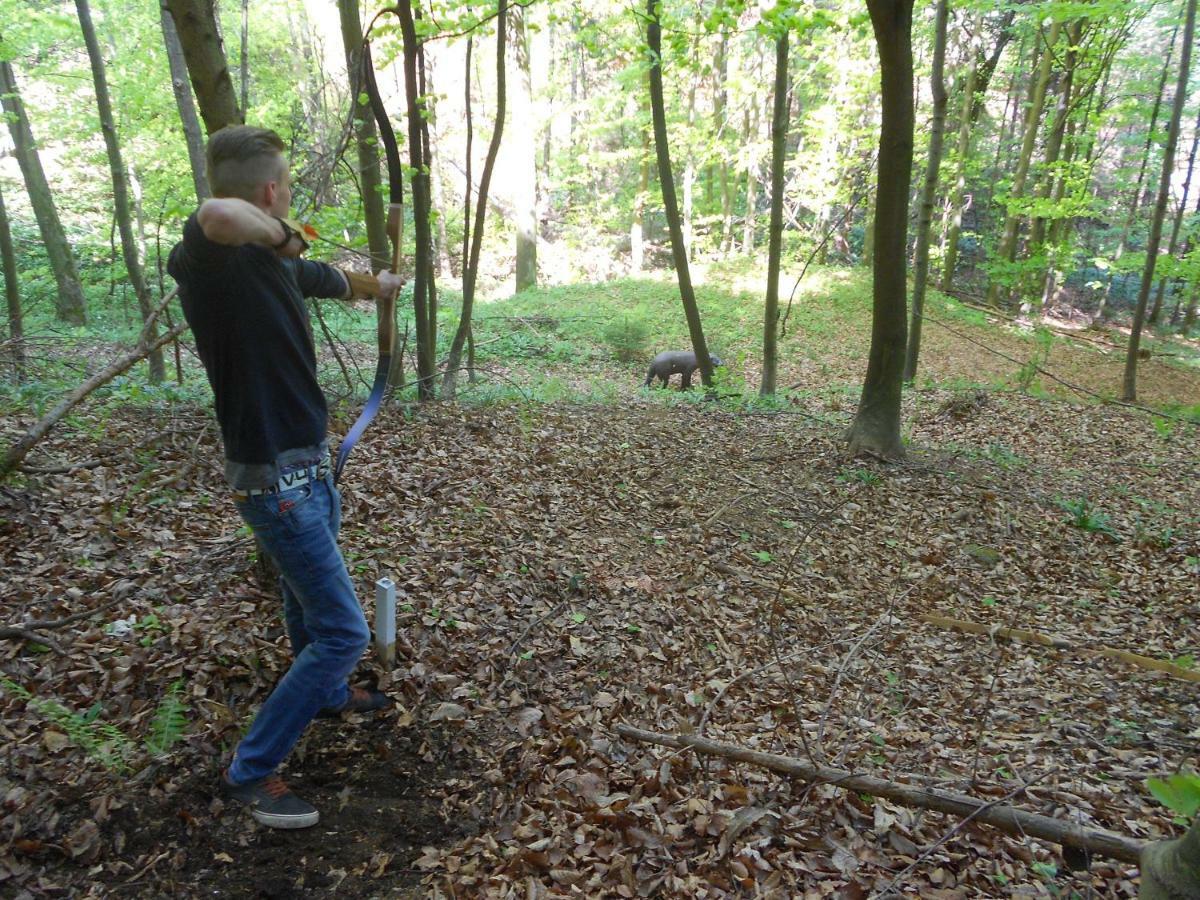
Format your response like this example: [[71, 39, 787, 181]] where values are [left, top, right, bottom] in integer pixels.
[[616, 725, 1145, 863]]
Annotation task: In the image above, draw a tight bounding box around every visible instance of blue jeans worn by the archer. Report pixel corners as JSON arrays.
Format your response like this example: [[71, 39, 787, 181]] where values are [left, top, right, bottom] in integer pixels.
[[229, 468, 371, 784]]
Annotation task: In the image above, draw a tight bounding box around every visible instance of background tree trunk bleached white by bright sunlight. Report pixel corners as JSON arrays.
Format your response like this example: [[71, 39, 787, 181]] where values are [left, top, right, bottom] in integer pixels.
[[510, 7, 538, 294]]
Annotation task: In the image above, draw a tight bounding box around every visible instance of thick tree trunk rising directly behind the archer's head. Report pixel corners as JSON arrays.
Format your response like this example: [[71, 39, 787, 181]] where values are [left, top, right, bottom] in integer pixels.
[[163, 0, 244, 134]]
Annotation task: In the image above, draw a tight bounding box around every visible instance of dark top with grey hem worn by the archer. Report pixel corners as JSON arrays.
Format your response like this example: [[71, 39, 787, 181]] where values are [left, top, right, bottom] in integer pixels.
[[167, 214, 346, 488]]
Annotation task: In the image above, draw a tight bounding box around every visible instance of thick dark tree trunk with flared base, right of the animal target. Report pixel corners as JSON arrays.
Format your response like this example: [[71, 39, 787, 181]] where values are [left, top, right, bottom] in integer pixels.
[[846, 0, 913, 458]]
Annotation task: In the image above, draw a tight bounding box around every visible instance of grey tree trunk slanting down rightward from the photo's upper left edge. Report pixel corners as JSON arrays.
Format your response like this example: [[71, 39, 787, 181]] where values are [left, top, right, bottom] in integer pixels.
[[0, 60, 88, 325]]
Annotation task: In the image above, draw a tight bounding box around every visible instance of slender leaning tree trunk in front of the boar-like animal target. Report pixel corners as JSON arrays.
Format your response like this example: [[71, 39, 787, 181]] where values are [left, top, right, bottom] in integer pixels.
[[646, 0, 713, 390]]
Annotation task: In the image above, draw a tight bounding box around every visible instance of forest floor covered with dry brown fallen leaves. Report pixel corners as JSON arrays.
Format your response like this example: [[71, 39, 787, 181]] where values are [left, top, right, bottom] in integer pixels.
[[0, 280, 1200, 898]]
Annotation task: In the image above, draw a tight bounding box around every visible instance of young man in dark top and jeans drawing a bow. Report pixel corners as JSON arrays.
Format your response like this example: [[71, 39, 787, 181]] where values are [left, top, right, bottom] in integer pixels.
[[168, 125, 403, 828]]
